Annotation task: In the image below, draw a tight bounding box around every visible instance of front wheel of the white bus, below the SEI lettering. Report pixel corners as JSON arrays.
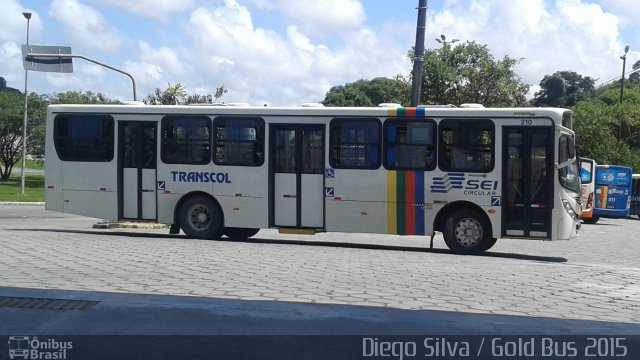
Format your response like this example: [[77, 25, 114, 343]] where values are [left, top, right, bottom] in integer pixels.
[[443, 209, 497, 255]]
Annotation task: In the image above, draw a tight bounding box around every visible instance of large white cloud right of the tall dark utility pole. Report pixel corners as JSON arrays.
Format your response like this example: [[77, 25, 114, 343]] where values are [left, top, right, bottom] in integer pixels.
[[427, 0, 622, 85]]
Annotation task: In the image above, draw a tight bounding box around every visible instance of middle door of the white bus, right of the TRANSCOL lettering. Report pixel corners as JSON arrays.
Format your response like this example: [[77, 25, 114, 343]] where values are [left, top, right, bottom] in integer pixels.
[[270, 124, 325, 229]]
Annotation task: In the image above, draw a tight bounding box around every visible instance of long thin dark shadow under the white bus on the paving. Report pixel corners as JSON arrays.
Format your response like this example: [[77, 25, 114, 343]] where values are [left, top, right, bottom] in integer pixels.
[[7, 229, 567, 263]]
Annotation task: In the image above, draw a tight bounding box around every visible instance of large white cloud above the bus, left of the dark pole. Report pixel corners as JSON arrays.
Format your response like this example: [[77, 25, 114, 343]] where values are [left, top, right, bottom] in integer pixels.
[[172, 0, 407, 105]]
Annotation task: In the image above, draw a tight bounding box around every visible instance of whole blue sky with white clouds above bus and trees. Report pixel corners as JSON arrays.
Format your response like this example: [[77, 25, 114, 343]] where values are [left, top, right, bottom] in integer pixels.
[[0, 0, 640, 105]]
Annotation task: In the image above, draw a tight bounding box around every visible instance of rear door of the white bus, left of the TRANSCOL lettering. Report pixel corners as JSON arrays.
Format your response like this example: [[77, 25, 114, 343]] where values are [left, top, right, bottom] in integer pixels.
[[118, 121, 157, 220]]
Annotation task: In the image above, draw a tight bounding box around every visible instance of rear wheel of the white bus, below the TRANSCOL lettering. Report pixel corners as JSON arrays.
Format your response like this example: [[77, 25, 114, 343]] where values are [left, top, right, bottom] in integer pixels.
[[178, 195, 224, 240]]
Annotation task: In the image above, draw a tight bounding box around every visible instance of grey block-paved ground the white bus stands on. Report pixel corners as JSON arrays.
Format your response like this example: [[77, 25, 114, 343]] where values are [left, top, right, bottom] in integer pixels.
[[0, 205, 640, 334]]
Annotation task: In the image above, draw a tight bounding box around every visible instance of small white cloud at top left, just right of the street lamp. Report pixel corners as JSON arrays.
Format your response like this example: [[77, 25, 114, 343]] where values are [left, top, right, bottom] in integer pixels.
[[49, 0, 123, 51]]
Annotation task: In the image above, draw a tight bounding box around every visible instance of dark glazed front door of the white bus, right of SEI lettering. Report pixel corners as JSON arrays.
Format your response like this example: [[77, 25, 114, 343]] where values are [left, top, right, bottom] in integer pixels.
[[502, 127, 554, 238]]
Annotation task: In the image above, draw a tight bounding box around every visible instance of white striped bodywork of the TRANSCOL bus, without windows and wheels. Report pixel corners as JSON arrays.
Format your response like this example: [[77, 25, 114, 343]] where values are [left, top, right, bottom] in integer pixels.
[[46, 105, 579, 250]]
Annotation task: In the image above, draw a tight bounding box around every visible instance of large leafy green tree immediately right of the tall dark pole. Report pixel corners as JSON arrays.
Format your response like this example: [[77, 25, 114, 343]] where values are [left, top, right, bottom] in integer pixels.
[[418, 40, 529, 107]]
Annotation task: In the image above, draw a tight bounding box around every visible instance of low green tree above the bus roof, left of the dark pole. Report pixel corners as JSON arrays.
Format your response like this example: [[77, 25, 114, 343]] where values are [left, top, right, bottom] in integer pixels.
[[322, 76, 411, 106]]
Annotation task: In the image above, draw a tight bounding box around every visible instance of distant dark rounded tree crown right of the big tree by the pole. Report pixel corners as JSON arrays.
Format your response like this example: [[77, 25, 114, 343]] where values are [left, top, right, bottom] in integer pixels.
[[531, 71, 596, 107]]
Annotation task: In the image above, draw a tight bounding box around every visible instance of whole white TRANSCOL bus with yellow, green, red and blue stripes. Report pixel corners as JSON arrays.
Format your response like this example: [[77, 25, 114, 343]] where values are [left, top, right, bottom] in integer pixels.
[[45, 105, 582, 254]]
